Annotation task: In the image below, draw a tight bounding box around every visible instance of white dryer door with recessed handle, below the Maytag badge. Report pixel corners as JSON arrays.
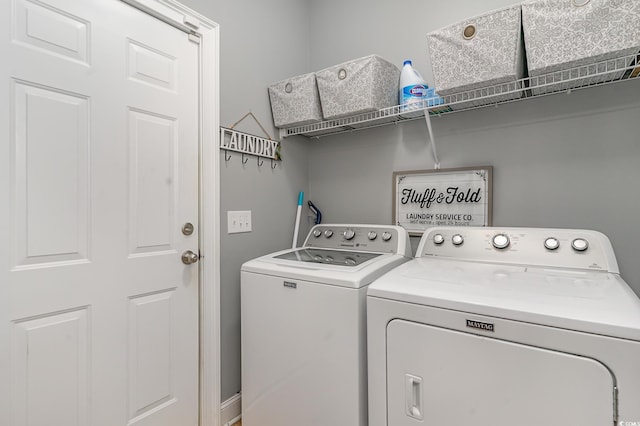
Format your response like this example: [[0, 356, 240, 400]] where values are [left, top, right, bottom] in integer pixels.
[[387, 320, 615, 426]]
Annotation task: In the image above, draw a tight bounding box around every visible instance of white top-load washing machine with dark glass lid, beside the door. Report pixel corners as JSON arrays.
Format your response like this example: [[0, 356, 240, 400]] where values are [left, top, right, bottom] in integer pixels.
[[241, 225, 411, 426]]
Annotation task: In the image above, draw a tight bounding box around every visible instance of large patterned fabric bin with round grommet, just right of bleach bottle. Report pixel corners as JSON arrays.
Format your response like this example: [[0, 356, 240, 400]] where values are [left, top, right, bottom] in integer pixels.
[[427, 5, 525, 109]]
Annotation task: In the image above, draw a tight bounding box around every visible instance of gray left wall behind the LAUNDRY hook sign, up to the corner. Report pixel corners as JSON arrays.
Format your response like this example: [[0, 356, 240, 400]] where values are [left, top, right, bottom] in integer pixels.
[[182, 0, 309, 401]]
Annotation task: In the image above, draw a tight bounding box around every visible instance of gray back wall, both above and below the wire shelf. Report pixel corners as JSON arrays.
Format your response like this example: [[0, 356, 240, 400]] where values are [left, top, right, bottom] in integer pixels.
[[309, 0, 640, 294]]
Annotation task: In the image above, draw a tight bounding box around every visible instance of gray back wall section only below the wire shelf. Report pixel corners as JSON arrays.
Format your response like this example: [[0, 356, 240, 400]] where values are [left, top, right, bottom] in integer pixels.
[[309, 82, 640, 276]]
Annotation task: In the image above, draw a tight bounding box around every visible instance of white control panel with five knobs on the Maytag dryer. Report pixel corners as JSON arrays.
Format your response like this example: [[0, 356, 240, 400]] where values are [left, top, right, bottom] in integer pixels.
[[417, 227, 619, 273]]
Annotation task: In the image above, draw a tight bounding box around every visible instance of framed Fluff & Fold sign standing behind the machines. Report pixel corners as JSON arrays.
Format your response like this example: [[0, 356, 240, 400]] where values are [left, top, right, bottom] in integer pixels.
[[393, 166, 493, 235]]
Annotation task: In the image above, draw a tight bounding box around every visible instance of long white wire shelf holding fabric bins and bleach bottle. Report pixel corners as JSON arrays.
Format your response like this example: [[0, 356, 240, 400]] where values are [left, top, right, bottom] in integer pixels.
[[280, 54, 640, 138]]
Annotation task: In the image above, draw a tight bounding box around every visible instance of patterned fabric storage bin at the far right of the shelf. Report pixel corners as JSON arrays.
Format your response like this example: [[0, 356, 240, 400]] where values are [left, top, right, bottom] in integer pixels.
[[522, 0, 640, 94]]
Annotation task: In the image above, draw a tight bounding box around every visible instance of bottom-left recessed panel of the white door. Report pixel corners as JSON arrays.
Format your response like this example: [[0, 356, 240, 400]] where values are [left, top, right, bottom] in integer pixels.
[[10, 308, 90, 426]]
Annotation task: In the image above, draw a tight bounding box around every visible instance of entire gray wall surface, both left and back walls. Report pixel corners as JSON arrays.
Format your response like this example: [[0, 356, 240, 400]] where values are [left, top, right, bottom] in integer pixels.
[[182, 0, 640, 400]]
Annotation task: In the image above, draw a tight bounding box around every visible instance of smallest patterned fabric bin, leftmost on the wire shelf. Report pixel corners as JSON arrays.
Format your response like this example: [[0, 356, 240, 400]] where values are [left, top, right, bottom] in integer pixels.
[[269, 73, 322, 128]]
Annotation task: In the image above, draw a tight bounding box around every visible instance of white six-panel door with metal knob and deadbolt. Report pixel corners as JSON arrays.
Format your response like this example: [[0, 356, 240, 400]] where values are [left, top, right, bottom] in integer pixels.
[[0, 0, 199, 426]]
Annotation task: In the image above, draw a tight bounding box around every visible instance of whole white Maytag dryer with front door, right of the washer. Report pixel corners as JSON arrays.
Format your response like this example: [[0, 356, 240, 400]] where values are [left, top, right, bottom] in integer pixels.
[[368, 227, 640, 426]]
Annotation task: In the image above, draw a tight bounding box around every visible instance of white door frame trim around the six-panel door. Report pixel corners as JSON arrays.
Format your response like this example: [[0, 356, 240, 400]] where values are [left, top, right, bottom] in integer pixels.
[[121, 0, 220, 426]]
